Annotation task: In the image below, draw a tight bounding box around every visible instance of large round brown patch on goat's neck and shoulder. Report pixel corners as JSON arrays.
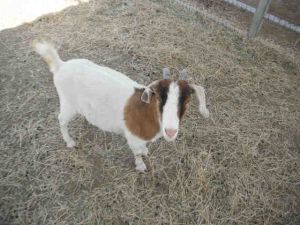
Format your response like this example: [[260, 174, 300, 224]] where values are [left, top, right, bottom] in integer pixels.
[[124, 89, 161, 140]]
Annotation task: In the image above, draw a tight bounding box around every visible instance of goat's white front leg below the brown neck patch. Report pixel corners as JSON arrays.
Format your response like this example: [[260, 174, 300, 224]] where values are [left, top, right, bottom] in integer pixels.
[[126, 133, 148, 172]]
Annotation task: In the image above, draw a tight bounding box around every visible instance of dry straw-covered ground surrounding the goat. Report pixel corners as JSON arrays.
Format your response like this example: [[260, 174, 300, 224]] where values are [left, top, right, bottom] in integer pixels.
[[0, 0, 300, 225]]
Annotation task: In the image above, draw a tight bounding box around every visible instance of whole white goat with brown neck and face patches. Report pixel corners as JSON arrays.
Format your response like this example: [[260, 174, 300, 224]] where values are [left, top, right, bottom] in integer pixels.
[[33, 41, 209, 171]]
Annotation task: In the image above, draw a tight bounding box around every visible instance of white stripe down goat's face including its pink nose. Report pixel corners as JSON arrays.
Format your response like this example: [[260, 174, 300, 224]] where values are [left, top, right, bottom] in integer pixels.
[[161, 82, 180, 141]]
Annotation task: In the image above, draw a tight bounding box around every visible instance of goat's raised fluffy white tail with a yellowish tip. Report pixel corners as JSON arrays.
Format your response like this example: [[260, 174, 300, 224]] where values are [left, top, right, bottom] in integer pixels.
[[32, 40, 63, 73]]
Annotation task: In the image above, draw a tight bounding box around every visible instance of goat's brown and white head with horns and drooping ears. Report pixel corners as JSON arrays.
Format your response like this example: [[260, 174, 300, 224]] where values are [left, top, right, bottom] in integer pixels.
[[141, 68, 209, 141]]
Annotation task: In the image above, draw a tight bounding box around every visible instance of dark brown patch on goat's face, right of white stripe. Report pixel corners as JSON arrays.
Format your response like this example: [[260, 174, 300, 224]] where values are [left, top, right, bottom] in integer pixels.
[[177, 80, 194, 121]]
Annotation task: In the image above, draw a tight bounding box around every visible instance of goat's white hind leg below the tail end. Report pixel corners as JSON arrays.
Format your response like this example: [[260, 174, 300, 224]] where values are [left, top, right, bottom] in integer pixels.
[[58, 102, 76, 148]]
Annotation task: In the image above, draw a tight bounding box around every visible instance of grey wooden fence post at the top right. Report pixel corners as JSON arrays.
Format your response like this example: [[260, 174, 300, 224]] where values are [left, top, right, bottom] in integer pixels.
[[248, 0, 272, 38]]
